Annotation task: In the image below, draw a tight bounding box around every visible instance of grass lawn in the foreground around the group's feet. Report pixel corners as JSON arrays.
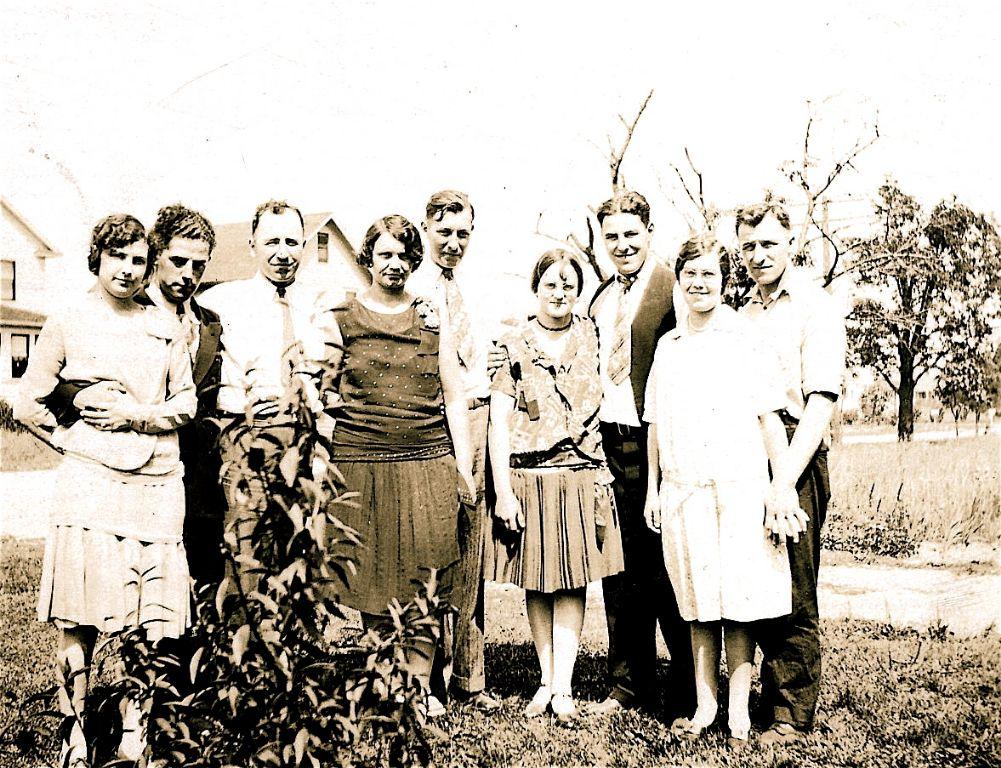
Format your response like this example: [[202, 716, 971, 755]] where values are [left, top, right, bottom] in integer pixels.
[[0, 539, 1001, 768]]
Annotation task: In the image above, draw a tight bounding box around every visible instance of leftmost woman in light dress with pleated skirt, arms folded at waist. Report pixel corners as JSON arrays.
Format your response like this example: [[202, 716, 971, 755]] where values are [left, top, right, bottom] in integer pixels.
[[14, 214, 196, 768]]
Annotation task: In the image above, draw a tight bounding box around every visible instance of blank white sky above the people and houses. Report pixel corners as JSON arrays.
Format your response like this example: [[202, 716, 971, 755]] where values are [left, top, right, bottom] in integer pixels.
[[0, 0, 1001, 308]]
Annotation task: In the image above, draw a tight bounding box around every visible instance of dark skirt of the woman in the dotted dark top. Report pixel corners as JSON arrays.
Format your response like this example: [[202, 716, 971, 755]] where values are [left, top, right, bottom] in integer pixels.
[[335, 455, 458, 615]]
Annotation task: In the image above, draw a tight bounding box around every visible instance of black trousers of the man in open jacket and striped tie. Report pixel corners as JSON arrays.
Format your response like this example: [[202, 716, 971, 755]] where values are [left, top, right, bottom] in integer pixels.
[[602, 423, 695, 717]]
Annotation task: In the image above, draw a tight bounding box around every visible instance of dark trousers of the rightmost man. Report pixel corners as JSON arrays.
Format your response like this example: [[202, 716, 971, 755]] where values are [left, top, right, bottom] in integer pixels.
[[753, 440, 831, 730]]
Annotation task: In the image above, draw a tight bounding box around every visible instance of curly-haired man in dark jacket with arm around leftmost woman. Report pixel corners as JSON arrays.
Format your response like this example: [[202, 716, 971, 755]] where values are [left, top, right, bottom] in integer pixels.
[[51, 204, 225, 589]]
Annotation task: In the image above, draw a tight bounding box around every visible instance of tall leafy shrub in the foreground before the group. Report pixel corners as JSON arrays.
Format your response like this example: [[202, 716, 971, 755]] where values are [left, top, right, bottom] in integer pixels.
[[2, 368, 445, 768]]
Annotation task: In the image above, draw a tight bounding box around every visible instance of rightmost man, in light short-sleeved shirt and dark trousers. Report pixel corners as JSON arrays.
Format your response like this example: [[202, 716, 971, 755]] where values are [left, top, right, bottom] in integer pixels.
[[737, 200, 847, 745]]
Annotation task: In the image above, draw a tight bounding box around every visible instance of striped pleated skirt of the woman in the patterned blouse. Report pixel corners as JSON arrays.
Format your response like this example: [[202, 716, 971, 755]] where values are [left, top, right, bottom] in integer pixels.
[[483, 469, 624, 592]]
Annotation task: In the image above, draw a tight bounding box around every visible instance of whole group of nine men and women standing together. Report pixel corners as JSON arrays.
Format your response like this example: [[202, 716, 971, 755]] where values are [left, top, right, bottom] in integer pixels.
[[15, 184, 845, 765]]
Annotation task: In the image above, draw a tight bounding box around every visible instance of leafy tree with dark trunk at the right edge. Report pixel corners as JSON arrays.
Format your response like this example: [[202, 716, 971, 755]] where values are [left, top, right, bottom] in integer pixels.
[[849, 181, 1001, 441]]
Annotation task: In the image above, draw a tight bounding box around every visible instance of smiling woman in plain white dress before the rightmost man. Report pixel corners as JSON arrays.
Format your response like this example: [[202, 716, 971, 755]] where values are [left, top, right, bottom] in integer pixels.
[[644, 236, 792, 741]]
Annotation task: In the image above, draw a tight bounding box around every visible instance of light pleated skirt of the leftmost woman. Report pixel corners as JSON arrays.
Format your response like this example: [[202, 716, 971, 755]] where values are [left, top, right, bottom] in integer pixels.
[[38, 457, 191, 641]]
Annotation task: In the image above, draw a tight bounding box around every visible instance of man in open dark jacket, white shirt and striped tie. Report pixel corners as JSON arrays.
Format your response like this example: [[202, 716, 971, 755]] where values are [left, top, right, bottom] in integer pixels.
[[591, 191, 695, 717]]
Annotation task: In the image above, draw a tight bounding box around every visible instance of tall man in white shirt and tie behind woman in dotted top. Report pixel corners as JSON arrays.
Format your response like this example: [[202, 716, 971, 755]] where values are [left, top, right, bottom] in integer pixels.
[[407, 189, 499, 711]]
